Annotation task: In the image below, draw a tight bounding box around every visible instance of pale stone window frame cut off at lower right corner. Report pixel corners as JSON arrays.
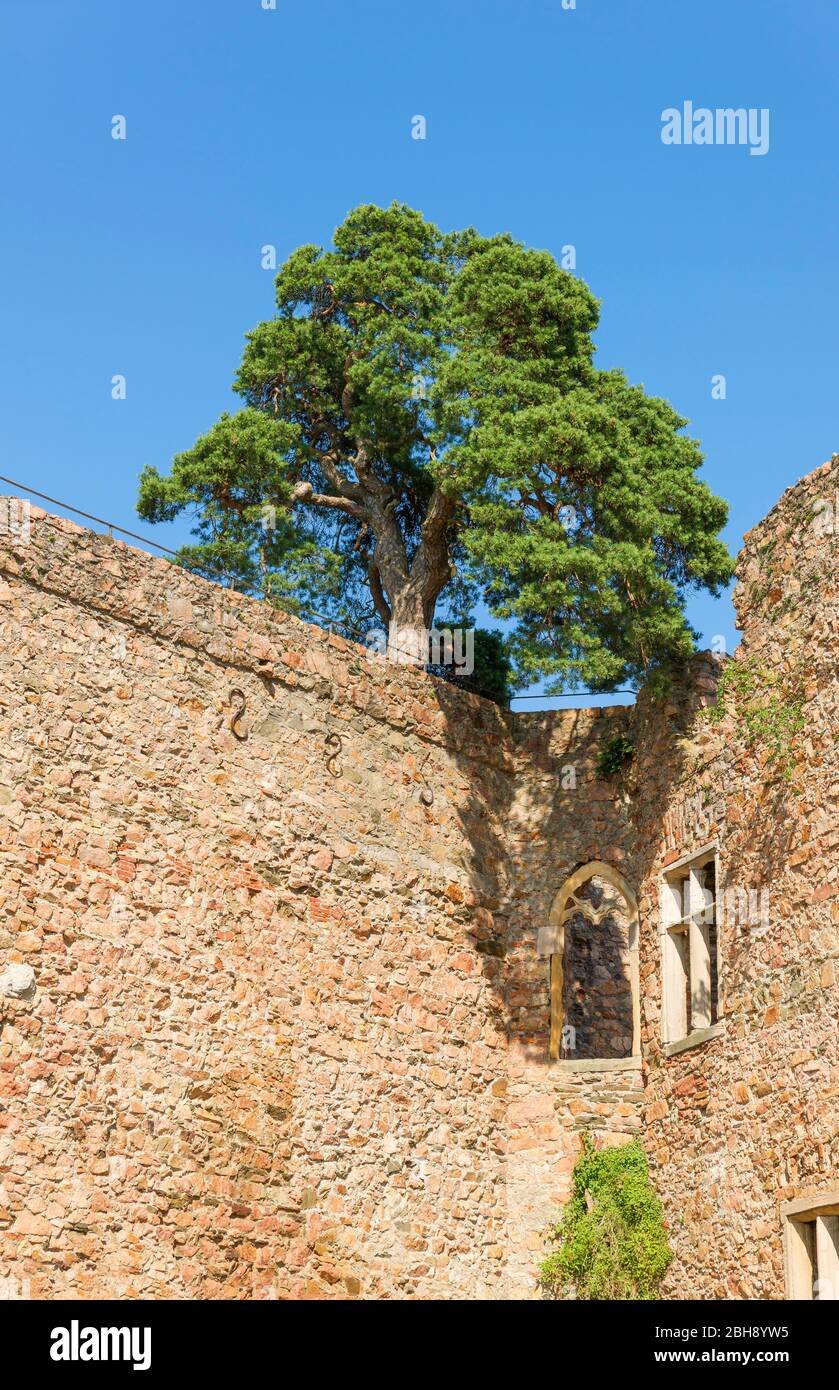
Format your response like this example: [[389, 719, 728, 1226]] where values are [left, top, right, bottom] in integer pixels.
[[781, 1190, 839, 1302]]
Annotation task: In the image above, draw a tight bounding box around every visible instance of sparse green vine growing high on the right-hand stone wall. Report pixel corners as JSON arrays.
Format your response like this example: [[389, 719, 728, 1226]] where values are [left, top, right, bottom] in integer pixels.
[[708, 659, 807, 781]]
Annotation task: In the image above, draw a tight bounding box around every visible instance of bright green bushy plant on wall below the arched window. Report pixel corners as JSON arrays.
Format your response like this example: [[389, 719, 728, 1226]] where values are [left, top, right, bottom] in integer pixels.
[[539, 1134, 672, 1301]]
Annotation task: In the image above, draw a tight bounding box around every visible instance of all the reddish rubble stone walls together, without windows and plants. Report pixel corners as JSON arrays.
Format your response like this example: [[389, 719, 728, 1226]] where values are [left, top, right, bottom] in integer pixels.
[[0, 460, 839, 1298]]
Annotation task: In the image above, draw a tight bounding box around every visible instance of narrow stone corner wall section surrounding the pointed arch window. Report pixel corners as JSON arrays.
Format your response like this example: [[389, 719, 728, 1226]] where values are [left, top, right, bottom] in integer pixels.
[[497, 706, 643, 1298]]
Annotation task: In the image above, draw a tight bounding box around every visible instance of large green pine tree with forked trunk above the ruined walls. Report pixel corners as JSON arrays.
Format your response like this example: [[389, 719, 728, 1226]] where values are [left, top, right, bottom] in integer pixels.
[[138, 204, 731, 691]]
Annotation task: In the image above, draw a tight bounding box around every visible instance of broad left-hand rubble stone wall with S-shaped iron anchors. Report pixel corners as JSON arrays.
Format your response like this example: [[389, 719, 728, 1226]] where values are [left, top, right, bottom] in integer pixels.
[[0, 516, 522, 1298]]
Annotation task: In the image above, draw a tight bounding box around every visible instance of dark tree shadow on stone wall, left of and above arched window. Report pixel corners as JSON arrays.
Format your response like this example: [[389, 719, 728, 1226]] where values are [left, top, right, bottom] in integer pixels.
[[422, 680, 644, 1063]]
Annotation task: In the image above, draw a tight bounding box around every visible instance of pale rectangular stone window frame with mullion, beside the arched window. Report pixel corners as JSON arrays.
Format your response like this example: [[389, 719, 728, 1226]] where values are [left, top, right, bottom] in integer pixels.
[[658, 842, 725, 1056]]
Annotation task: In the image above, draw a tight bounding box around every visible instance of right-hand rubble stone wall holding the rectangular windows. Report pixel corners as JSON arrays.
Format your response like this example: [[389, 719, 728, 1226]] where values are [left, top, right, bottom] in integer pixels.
[[629, 457, 839, 1298]]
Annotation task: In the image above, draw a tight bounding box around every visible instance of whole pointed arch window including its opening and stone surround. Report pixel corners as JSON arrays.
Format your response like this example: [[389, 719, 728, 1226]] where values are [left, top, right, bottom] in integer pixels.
[[538, 860, 640, 1068]]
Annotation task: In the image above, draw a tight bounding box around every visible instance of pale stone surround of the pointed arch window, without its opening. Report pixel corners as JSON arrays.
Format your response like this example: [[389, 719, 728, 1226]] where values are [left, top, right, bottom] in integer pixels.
[[536, 859, 642, 1072]]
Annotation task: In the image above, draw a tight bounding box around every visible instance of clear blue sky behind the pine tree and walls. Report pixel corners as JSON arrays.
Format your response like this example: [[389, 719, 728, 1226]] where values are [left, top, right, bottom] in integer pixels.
[[0, 0, 839, 700]]
